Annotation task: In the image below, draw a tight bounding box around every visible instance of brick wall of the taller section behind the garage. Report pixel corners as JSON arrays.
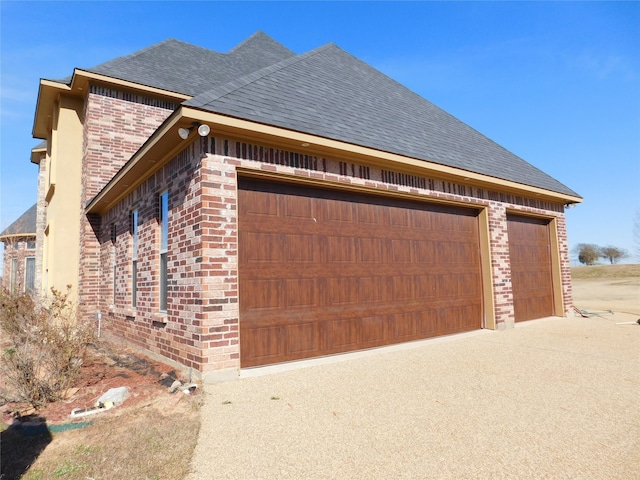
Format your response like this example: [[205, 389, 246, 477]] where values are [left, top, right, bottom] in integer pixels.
[[78, 85, 177, 314]]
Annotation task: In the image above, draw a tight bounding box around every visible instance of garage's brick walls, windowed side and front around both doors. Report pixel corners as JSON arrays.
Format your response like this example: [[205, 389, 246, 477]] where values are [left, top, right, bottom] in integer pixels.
[[95, 137, 571, 373]]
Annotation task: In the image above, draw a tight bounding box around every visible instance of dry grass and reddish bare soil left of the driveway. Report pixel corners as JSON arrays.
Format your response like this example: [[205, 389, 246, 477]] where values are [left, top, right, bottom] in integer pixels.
[[0, 345, 202, 480]]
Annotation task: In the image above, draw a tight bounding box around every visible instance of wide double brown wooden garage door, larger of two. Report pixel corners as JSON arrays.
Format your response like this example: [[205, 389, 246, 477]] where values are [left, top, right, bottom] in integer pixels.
[[238, 179, 482, 367]]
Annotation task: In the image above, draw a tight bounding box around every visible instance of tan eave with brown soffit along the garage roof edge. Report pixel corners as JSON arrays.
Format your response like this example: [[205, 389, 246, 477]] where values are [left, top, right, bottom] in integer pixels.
[[85, 105, 582, 214]]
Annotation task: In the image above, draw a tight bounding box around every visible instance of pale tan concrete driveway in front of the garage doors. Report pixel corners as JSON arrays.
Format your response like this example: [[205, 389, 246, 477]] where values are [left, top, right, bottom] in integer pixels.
[[189, 314, 640, 479]]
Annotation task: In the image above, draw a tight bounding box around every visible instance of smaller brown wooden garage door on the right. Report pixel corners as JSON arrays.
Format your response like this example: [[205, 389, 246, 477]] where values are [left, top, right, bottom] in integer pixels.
[[507, 215, 554, 322]]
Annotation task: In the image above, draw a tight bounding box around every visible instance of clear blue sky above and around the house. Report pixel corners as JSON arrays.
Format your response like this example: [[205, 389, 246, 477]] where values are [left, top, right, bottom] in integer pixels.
[[0, 0, 640, 270]]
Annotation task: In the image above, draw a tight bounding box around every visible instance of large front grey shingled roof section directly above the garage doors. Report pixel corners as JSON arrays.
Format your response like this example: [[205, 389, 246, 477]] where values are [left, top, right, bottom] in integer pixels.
[[184, 44, 579, 196]]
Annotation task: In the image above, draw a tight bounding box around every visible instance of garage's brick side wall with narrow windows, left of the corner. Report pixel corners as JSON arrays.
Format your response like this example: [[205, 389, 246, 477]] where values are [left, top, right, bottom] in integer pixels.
[[99, 141, 212, 370]]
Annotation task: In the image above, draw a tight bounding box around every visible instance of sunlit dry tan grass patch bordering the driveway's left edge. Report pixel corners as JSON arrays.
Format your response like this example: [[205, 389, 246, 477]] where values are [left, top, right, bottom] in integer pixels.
[[13, 398, 200, 480]]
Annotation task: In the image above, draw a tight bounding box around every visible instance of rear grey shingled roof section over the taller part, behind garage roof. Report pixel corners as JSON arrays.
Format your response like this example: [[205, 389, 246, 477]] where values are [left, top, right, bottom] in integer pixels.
[[76, 32, 295, 95]]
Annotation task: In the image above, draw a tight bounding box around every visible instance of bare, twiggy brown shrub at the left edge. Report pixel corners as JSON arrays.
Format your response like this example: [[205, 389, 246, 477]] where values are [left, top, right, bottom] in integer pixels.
[[0, 286, 94, 408]]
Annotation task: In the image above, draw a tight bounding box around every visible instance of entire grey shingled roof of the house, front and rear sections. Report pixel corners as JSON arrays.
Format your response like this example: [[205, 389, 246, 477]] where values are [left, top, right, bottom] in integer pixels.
[[61, 32, 579, 197]]
